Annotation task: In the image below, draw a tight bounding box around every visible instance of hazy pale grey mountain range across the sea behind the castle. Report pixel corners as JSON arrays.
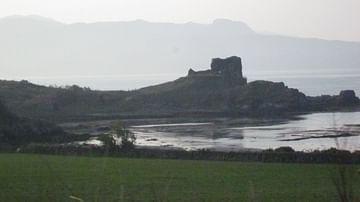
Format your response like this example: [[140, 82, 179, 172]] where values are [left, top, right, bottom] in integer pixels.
[[0, 16, 360, 79]]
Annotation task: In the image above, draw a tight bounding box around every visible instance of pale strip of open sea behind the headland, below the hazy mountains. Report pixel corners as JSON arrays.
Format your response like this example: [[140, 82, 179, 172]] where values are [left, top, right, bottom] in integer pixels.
[[0, 71, 360, 96]]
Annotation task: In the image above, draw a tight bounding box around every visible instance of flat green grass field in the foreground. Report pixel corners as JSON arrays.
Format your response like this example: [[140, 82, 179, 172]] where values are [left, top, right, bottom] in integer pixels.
[[0, 154, 360, 202]]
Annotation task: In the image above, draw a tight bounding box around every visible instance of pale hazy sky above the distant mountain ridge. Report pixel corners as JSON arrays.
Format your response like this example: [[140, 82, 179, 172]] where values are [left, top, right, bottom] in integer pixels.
[[0, 0, 360, 41]]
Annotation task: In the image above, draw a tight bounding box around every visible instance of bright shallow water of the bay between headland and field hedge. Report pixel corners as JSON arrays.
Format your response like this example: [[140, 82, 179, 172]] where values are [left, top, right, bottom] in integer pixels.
[[131, 112, 360, 151]]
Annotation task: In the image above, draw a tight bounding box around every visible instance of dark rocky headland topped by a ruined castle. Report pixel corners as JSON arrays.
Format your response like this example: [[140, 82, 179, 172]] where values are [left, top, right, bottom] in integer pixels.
[[0, 56, 359, 121]]
